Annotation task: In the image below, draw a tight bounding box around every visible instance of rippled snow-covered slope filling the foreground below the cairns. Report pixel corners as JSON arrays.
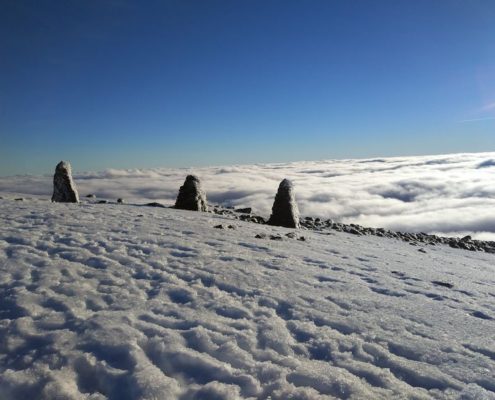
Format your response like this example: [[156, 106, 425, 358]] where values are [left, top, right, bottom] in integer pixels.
[[0, 198, 495, 400]]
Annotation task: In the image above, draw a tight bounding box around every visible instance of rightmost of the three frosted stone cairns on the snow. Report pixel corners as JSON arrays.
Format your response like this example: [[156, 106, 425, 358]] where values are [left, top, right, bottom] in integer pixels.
[[268, 179, 300, 228]]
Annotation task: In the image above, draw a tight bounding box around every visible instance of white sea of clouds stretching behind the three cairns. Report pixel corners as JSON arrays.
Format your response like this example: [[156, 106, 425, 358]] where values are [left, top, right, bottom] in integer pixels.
[[0, 153, 495, 240]]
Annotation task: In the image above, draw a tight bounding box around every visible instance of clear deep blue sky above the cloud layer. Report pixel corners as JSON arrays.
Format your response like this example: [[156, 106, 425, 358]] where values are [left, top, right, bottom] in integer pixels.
[[0, 0, 495, 175]]
